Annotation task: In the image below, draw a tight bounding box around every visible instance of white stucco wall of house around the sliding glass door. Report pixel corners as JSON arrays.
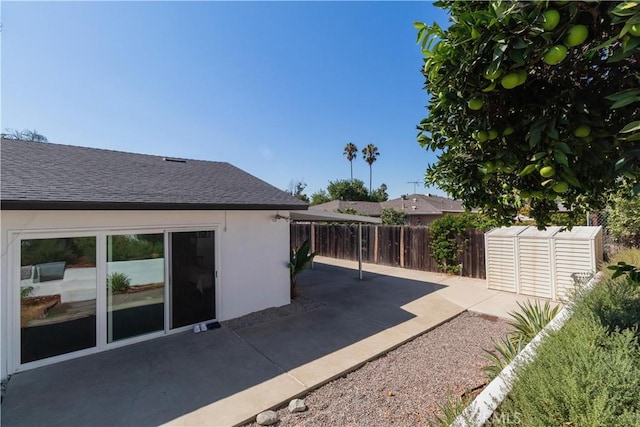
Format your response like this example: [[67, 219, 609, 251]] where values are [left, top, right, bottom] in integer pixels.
[[0, 211, 290, 378]]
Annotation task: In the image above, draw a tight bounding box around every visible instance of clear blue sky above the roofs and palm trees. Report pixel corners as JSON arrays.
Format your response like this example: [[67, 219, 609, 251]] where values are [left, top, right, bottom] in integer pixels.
[[0, 1, 447, 201]]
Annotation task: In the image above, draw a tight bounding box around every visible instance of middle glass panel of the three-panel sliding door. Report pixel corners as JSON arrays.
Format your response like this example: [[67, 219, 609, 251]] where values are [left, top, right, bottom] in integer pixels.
[[107, 233, 164, 342]]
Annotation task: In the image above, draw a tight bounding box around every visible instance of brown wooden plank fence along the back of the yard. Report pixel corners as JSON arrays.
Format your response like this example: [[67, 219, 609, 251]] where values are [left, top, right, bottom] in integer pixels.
[[291, 223, 486, 279]]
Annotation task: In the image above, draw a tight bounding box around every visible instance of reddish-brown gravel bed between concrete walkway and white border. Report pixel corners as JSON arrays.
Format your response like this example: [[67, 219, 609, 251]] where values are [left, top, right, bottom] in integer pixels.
[[247, 313, 510, 427]]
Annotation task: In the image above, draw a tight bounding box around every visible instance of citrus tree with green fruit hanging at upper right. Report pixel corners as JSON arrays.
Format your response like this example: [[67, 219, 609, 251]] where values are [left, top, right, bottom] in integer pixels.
[[415, 0, 640, 226]]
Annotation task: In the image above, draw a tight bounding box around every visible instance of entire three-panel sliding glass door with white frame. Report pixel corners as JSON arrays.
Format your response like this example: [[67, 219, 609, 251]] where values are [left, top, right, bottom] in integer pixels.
[[10, 229, 216, 368]]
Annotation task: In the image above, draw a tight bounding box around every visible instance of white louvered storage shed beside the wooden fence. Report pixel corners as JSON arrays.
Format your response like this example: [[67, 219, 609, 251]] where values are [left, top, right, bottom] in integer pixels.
[[485, 226, 603, 300]]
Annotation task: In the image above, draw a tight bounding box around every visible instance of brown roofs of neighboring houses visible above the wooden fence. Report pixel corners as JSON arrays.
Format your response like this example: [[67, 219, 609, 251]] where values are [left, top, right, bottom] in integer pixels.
[[309, 194, 465, 216]]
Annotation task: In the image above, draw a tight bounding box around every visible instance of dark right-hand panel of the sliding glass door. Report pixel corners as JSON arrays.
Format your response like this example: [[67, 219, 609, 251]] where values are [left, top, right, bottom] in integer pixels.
[[170, 231, 216, 328]]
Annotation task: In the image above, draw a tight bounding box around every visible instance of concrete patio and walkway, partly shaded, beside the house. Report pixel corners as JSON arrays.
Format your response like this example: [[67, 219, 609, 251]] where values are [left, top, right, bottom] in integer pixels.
[[1, 257, 552, 426]]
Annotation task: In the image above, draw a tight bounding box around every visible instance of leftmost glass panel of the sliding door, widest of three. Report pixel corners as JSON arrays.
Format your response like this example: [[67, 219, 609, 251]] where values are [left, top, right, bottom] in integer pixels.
[[19, 236, 97, 363]]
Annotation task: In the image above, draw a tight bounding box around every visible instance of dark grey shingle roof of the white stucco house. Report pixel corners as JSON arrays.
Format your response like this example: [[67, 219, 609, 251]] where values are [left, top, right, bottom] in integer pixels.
[[0, 139, 307, 210]]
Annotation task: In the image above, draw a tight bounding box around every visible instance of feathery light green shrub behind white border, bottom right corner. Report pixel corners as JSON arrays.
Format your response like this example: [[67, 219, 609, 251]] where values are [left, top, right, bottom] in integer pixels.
[[496, 270, 640, 426]]
